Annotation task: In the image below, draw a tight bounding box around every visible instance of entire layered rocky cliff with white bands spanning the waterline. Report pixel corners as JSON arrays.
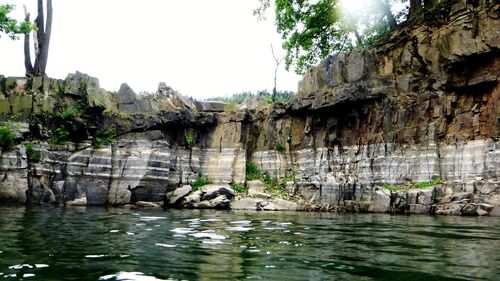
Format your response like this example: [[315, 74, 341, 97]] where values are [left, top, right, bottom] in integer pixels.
[[0, 1, 500, 215]]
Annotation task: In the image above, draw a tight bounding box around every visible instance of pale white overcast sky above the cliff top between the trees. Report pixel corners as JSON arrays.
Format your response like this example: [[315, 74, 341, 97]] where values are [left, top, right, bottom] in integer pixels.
[[0, 0, 300, 98]]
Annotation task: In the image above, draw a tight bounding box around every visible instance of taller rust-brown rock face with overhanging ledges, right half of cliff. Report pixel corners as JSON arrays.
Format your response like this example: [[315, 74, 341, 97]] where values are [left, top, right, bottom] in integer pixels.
[[245, 1, 500, 211]]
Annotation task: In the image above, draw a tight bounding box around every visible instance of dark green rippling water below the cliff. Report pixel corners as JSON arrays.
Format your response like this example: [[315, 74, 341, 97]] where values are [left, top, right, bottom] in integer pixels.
[[0, 207, 500, 281]]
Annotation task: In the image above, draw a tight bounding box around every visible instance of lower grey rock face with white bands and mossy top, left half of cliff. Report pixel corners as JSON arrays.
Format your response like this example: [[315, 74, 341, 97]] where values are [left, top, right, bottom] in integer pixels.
[[0, 73, 246, 205]]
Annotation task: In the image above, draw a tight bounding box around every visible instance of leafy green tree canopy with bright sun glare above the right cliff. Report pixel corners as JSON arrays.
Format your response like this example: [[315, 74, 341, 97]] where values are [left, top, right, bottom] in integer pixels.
[[254, 0, 454, 74]]
